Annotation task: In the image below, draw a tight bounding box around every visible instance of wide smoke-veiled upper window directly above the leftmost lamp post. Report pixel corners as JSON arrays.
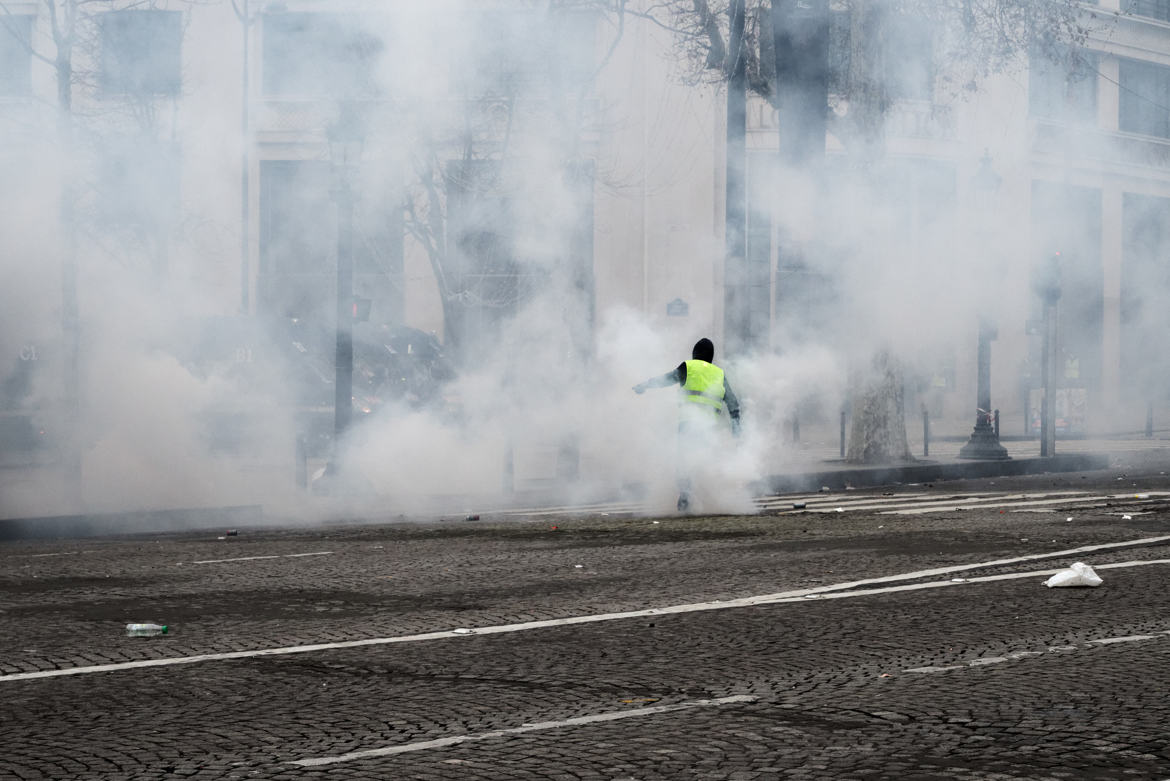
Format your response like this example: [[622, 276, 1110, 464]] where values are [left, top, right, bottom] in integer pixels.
[[262, 13, 385, 97]]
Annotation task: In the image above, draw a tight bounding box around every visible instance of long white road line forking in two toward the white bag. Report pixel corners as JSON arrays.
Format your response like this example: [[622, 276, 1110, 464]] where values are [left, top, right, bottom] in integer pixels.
[[0, 535, 1170, 683]]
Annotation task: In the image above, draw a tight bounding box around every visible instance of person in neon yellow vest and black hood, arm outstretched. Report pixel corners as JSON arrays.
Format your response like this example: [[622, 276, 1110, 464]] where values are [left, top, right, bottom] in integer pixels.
[[634, 339, 739, 512]]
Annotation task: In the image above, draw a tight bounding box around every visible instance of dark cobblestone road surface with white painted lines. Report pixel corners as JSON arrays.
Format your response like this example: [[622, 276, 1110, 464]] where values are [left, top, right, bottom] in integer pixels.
[[0, 464, 1170, 781]]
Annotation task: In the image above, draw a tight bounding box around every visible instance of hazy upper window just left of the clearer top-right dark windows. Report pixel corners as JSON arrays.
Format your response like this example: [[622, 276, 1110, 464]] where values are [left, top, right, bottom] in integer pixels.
[[1028, 49, 1097, 124]]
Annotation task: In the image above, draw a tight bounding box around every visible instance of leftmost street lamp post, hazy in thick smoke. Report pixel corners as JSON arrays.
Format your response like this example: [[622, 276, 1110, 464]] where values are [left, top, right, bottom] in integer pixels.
[[326, 103, 364, 475]]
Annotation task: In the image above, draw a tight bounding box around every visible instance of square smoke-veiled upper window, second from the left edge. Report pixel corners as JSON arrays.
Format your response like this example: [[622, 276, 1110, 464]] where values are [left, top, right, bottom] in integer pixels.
[[98, 11, 183, 96]]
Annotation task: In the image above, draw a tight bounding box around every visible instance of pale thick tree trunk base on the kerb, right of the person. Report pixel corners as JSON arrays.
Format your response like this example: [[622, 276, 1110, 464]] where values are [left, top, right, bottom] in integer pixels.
[[845, 350, 914, 464]]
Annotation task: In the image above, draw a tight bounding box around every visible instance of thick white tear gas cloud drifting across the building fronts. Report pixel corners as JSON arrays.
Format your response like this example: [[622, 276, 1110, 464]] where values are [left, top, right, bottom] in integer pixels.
[[0, 0, 1151, 518]]
